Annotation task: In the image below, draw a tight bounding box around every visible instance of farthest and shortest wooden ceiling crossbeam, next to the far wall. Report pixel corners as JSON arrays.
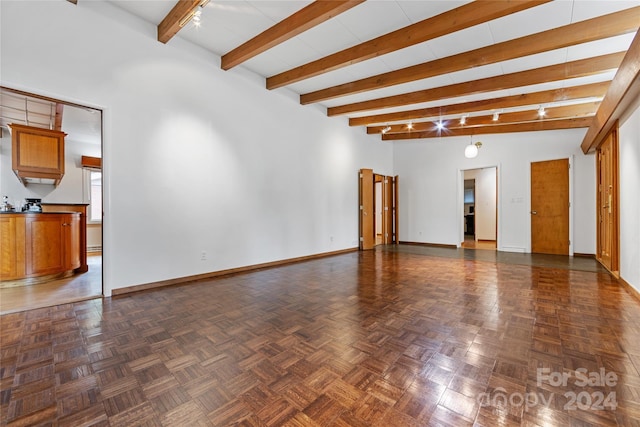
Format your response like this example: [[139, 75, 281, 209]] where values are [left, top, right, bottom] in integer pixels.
[[382, 117, 593, 141]]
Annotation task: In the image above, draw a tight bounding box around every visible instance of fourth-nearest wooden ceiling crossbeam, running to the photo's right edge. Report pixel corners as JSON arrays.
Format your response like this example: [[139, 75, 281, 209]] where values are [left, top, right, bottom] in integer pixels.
[[300, 6, 640, 105]]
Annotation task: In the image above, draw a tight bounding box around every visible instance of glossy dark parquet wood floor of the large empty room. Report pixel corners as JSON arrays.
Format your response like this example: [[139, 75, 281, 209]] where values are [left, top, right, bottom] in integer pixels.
[[0, 250, 640, 427]]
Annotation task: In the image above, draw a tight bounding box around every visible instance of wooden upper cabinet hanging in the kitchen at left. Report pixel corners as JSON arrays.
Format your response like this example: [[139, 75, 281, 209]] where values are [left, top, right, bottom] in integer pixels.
[[10, 124, 66, 185]]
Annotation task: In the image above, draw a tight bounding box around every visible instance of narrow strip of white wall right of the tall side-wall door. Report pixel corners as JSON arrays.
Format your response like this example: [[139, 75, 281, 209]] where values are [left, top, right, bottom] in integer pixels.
[[619, 103, 640, 292]]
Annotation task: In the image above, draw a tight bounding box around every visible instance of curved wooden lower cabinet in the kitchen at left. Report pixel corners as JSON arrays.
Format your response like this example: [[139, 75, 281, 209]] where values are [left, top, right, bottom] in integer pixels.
[[0, 213, 80, 280]]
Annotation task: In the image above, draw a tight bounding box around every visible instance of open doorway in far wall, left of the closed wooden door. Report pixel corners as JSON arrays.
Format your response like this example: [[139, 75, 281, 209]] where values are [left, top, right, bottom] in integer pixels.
[[461, 166, 498, 250]]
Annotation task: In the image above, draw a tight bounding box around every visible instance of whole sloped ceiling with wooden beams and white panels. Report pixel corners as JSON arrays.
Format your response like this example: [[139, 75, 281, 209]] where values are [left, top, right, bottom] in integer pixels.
[[118, 0, 640, 145]]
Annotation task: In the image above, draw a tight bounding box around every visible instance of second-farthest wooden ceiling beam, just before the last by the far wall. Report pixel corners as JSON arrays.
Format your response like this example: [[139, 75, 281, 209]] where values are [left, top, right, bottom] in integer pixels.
[[367, 102, 600, 135]]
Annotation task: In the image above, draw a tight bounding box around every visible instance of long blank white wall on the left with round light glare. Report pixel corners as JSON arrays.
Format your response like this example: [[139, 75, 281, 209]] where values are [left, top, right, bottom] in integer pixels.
[[0, 1, 393, 295]]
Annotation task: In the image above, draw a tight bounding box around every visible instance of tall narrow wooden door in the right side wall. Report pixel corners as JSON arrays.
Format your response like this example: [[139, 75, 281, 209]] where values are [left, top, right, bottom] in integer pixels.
[[596, 132, 618, 272]]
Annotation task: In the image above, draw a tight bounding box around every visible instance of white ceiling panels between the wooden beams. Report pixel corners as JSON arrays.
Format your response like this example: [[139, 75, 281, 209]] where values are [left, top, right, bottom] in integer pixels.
[[106, 0, 640, 137]]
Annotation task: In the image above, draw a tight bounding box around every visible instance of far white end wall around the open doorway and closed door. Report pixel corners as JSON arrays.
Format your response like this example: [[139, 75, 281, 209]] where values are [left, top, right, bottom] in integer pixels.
[[394, 129, 596, 254]]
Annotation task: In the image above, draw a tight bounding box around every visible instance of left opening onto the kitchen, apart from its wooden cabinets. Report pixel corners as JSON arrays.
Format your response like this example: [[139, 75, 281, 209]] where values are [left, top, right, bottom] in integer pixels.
[[0, 87, 104, 314]]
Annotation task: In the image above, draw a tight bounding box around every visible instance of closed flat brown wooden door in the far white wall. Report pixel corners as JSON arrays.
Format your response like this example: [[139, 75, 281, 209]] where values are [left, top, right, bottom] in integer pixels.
[[531, 159, 569, 255]]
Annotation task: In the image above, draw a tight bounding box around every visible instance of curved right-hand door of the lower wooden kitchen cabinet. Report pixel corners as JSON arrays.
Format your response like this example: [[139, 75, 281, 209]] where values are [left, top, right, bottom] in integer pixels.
[[26, 214, 65, 275]]
